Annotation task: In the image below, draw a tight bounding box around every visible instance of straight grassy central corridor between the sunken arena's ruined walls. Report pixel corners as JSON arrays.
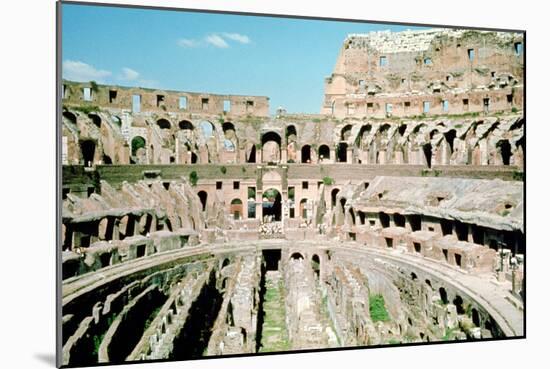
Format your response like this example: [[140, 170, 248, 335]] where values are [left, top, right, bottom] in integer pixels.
[[260, 271, 290, 352]]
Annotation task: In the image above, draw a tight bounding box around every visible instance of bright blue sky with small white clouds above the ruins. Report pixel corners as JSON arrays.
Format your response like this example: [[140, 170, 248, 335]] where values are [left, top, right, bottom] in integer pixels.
[[62, 4, 430, 113]]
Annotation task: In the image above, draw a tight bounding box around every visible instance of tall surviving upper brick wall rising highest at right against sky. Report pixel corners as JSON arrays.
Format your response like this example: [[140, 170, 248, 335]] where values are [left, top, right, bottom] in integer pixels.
[[321, 29, 524, 118]]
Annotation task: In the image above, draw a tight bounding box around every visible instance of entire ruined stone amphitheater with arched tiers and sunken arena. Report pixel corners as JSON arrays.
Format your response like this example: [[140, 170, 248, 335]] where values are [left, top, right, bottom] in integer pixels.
[[59, 30, 525, 365]]
